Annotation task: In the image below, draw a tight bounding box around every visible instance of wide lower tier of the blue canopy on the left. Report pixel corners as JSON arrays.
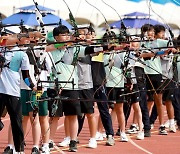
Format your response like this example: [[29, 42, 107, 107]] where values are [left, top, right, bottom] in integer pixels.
[[2, 12, 72, 29]]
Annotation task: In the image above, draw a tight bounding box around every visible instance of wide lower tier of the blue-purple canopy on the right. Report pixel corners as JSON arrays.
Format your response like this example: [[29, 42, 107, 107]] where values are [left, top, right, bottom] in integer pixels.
[[110, 18, 163, 28]]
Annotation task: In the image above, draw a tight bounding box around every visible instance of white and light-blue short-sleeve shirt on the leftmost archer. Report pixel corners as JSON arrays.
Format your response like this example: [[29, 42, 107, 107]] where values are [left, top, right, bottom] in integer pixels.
[[0, 47, 30, 97]]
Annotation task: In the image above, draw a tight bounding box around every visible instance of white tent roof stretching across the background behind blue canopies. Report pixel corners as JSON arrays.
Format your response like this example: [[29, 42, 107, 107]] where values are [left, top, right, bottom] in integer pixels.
[[0, 0, 180, 27]]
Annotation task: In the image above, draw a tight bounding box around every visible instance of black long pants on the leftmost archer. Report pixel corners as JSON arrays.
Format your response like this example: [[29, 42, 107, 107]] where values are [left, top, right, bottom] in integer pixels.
[[0, 94, 24, 152]]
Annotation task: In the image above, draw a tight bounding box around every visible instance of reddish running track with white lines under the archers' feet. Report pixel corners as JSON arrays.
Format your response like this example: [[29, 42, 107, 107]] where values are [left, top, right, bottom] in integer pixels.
[[0, 106, 180, 154]]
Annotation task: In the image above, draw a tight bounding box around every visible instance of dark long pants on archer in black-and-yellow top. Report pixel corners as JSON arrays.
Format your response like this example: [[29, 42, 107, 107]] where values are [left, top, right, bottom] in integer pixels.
[[78, 86, 114, 136]]
